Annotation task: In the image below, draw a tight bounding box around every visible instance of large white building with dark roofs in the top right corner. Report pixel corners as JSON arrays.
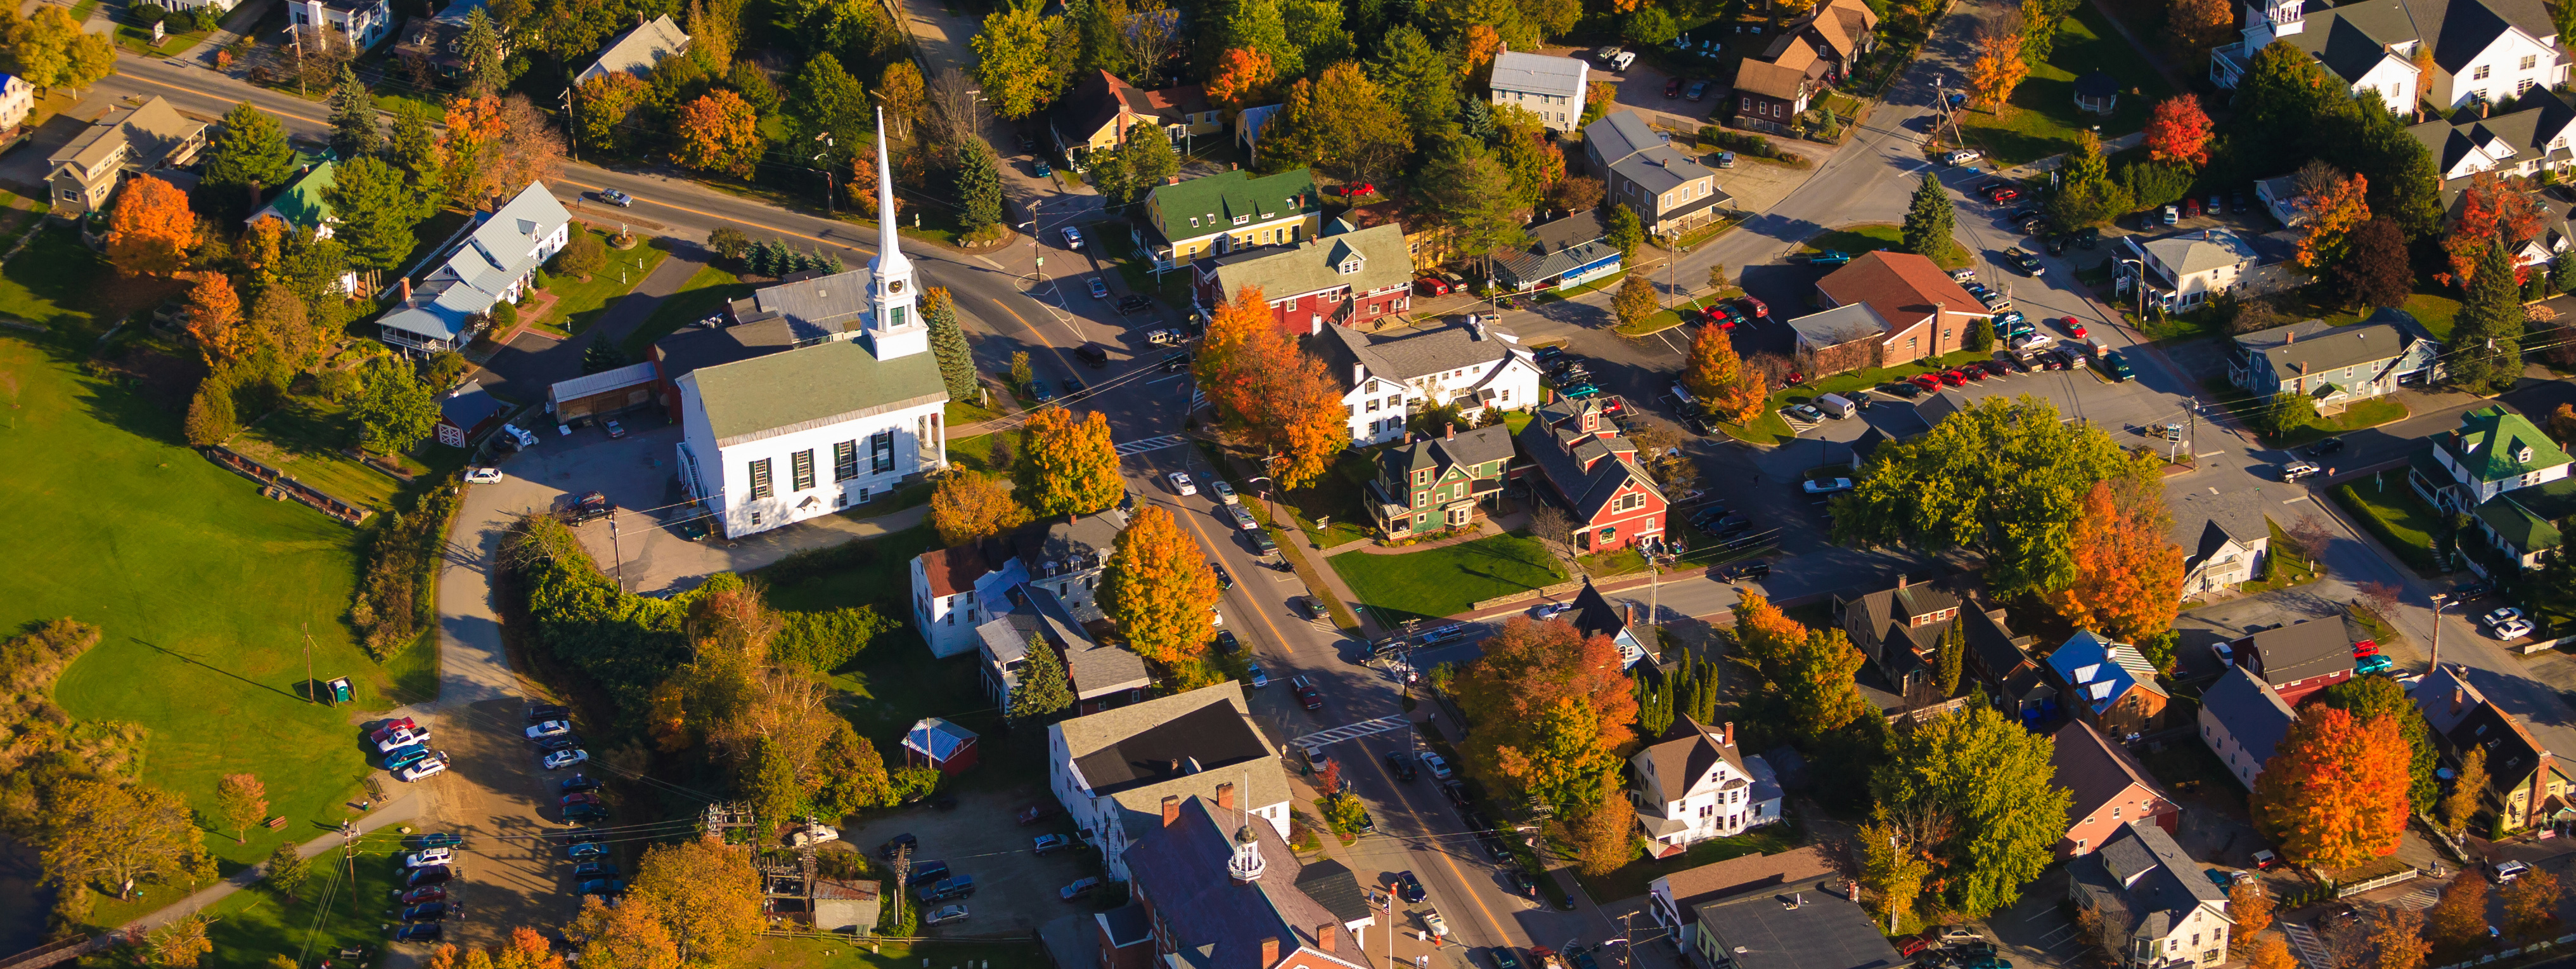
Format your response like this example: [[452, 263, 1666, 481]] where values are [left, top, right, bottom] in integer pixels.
[[2210, 0, 2568, 111]]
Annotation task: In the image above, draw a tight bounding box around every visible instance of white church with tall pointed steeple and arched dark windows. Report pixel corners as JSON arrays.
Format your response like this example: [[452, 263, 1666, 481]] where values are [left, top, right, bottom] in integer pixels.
[[678, 119, 948, 538]]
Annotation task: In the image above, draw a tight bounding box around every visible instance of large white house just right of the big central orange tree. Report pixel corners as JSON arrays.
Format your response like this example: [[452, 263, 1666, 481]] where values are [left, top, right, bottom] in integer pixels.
[[1309, 320, 1538, 446]]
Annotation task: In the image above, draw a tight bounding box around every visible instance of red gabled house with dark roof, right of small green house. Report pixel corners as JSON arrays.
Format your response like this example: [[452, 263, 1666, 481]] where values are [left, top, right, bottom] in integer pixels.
[[1520, 400, 1666, 552]]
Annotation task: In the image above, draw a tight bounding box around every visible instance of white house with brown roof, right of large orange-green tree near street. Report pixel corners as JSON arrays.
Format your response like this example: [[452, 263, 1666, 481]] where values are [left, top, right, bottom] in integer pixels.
[[1628, 717, 1780, 858]]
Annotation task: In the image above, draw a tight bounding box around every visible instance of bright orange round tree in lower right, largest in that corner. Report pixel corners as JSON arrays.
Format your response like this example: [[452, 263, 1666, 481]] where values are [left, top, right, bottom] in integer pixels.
[[2251, 706, 2411, 869]]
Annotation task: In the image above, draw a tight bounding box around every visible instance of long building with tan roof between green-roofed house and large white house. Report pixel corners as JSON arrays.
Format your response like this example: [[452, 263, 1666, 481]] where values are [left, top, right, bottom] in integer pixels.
[[1190, 219, 1414, 335]]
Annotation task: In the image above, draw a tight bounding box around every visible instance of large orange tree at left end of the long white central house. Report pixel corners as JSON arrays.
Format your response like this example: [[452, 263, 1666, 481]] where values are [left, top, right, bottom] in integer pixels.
[[1195, 286, 1350, 490]]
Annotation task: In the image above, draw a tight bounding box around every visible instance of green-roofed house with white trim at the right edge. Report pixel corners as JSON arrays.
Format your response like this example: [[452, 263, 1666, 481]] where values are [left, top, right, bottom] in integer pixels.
[[2406, 407, 2576, 575]]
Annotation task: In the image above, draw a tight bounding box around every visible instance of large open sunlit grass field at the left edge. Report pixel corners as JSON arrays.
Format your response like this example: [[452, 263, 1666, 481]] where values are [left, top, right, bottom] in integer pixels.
[[0, 337, 404, 871]]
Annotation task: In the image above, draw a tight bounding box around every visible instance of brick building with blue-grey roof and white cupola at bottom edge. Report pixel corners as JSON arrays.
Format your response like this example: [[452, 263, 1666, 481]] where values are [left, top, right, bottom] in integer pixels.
[[1126, 797, 1368, 969]]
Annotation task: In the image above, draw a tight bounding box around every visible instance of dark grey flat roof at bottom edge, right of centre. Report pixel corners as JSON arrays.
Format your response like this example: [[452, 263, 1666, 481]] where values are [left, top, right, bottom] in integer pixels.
[[1692, 881, 1909, 969]]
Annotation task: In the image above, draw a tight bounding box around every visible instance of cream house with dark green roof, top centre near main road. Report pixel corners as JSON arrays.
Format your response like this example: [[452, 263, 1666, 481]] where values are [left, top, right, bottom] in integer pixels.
[[1138, 167, 1324, 271]]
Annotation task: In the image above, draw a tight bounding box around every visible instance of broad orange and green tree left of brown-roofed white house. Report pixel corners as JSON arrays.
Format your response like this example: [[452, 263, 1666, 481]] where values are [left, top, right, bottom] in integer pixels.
[[1455, 616, 1636, 814]]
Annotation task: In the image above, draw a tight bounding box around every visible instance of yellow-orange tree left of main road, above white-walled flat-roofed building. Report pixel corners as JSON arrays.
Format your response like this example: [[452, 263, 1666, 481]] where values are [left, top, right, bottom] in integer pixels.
[[1100, 505, 1218, 665]]
